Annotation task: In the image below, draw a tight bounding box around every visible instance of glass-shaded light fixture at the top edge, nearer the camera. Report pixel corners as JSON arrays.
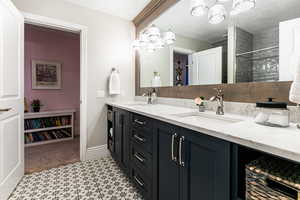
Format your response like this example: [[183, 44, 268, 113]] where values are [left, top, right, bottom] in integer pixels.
[[191, 0, 256, 24]]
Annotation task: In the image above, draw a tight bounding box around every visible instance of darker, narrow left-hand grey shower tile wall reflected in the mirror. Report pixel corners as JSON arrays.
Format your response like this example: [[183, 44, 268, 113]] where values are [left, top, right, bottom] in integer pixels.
[[236, 27, 253, 83]]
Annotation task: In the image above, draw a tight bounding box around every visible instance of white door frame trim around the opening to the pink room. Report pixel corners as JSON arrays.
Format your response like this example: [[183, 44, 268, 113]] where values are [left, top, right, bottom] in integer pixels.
[[22, 12, 88, 161]]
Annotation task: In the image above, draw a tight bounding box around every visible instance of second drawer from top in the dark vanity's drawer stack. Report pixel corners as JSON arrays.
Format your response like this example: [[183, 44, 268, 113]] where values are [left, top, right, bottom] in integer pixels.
[[131, 128, 152, 153]]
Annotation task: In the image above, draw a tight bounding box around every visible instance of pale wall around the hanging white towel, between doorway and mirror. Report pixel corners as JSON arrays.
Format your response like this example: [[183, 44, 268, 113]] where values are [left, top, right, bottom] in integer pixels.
[[12, 0, 135, 147]]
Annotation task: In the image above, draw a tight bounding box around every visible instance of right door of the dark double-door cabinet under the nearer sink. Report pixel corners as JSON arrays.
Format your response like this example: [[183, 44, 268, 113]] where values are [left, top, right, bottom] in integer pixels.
[[181, 130, 230, 200]]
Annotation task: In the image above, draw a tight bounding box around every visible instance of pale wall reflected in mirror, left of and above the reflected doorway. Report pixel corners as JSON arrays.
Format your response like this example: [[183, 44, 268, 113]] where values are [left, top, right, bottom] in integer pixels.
[[140, 34, 211, 87]]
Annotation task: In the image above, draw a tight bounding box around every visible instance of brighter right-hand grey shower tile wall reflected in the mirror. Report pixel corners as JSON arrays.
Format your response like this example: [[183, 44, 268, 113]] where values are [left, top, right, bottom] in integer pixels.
[[252, 27, 279, 81]]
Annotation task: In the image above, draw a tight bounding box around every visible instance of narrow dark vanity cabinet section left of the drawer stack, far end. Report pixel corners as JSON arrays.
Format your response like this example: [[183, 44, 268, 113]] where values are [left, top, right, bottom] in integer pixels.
[[113, 108, 130, 172]]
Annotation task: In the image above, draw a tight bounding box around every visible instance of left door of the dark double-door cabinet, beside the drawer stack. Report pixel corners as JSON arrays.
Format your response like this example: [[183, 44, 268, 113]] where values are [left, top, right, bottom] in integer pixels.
[[156, 123, 180, 200]]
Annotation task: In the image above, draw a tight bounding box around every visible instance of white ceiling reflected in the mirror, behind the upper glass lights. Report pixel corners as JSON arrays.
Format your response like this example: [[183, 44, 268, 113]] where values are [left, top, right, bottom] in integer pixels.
[[153, 0, 300, 41]]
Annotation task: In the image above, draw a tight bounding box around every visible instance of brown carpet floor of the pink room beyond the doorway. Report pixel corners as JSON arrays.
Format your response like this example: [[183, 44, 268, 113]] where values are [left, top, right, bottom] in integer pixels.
[[25, 137, 80, 174]]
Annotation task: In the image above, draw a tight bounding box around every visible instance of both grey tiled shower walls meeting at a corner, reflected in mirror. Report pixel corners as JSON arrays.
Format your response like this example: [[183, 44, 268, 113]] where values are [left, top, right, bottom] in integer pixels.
[[236, 27, 279, 82]]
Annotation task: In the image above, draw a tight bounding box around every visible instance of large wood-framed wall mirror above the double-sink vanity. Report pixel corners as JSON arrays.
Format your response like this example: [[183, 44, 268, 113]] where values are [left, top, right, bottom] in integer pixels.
[[138, 0, 300, 88]]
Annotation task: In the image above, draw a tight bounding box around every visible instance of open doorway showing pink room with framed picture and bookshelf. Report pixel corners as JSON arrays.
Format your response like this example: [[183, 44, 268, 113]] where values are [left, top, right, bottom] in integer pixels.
[[24, 23, 80, 173]]
